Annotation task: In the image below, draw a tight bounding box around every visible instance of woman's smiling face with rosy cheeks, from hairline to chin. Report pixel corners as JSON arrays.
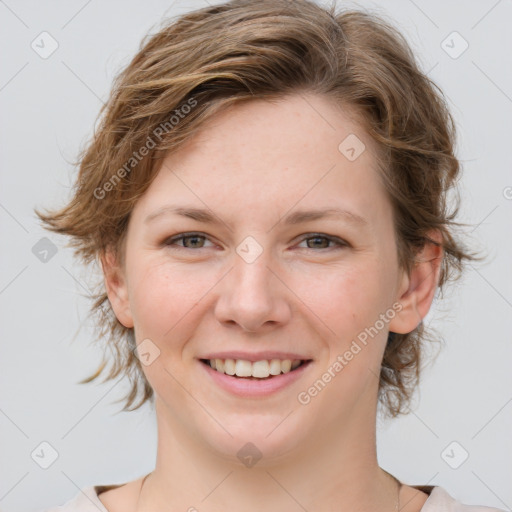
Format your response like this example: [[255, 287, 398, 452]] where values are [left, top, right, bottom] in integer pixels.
[[104, 95, 433, 464]]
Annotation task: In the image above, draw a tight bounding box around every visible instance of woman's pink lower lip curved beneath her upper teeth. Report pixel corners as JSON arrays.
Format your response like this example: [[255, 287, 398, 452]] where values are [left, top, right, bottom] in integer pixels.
[[199, 361, 311, 398]]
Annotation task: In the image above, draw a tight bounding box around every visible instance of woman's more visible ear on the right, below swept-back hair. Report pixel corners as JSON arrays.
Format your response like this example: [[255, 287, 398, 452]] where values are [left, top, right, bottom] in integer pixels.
[[389, 230, 443, 334]]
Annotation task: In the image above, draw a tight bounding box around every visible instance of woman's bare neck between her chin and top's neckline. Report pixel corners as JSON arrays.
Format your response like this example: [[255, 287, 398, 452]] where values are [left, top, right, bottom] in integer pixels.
[[137, 397, 398, 512]]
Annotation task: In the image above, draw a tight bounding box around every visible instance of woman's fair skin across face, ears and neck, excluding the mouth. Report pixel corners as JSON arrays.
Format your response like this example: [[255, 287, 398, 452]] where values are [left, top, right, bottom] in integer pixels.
[[100, 94, 442, 512]]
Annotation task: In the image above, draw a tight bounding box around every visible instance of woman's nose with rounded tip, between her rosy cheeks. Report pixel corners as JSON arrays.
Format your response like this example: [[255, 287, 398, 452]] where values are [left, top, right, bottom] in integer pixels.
[[215, 252, 291, 332]]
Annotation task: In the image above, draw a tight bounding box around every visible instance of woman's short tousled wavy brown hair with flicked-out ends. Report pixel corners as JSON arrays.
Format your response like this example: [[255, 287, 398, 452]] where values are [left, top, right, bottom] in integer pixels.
[[36, 0, 475, 416]]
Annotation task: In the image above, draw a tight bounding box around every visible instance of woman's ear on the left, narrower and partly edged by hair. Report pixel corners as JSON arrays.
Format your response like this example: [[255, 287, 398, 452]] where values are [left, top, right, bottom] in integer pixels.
[[100, 248, 133, 328]]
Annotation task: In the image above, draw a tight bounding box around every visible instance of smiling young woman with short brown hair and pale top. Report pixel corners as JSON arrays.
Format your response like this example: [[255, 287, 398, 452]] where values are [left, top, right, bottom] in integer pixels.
[[38, 0, 504, 512]]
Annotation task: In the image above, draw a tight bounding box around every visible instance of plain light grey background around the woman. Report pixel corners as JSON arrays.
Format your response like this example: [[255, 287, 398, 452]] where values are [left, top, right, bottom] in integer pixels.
[[0, 0, 512, 512]]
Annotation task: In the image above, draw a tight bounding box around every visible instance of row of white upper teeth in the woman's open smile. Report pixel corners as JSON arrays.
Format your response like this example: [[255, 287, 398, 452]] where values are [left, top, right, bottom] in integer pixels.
[[209, 359, 301, 379]]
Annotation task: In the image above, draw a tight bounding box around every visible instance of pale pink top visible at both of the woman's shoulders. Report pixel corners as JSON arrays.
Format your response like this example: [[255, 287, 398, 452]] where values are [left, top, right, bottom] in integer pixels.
[[41, 484, 505, 512]]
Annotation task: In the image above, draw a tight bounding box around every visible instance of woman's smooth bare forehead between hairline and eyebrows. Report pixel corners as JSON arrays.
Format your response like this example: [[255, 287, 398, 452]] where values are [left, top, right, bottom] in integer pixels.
[[137, 94, 389, 231]]
